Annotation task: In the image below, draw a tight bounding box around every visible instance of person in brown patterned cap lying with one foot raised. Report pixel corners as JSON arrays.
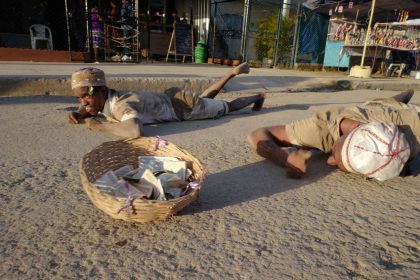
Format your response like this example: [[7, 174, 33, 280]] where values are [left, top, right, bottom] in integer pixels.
[[68, 63, 265, 138]]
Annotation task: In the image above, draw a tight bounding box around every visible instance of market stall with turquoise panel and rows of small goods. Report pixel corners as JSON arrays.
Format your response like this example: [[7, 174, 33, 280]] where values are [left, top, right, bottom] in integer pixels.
[[304, 0, 420, 74]]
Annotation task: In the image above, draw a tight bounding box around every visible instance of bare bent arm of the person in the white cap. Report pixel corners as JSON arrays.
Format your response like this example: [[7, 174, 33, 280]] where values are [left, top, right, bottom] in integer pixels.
[[247, 125, 312, 178]]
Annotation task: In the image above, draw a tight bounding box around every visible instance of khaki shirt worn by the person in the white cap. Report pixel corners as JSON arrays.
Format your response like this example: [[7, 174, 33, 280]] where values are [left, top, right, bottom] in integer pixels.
[[286, 98, 420, 157]]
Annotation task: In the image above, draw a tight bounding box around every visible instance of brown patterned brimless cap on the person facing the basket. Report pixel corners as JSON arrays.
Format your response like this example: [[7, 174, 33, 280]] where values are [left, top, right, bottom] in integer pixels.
[[71, 68, 106, 89]]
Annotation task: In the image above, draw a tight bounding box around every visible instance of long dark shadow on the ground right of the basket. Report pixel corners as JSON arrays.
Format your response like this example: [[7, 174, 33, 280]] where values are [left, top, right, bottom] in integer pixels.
[[181, 151, 335, 214]]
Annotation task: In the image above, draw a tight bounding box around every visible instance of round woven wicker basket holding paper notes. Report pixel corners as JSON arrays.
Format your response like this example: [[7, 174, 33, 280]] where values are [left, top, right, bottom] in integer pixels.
[[79, 137, 205, 223]]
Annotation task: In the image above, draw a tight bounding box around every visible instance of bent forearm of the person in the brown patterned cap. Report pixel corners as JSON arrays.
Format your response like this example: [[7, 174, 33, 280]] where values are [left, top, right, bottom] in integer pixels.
[[86, 118, 143, 138]]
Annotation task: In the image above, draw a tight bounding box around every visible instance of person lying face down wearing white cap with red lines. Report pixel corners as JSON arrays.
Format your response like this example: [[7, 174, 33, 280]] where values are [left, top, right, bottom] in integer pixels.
[[247, 90, 420, 181]]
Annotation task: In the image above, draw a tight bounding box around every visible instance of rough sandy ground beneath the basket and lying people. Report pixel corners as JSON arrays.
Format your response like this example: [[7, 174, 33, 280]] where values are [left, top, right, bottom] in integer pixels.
[[0, 88, 420, 279]]
